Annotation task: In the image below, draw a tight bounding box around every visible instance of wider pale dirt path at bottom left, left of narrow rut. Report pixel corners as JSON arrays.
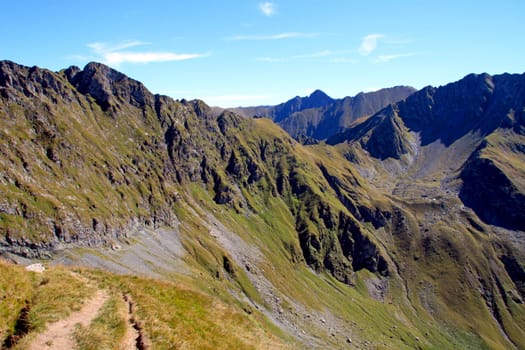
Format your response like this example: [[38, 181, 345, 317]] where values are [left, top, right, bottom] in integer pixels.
[[29, 290, 109, 350]]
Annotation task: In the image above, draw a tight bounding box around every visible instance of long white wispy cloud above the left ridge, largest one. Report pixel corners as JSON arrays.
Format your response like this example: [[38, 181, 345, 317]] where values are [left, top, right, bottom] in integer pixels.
[[87, 40, 209, 66]]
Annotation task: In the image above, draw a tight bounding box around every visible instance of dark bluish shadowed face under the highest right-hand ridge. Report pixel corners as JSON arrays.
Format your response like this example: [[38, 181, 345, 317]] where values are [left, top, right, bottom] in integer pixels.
[[397, 74, 525, 146]]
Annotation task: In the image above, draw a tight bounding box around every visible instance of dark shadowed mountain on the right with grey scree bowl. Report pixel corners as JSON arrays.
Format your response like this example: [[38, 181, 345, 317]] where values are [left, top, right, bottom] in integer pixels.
[[327, 74, 525, 230]]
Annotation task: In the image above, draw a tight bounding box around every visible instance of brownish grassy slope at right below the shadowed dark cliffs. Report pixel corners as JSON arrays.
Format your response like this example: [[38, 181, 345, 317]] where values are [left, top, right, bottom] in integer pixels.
[[332, 129, 525, 349]]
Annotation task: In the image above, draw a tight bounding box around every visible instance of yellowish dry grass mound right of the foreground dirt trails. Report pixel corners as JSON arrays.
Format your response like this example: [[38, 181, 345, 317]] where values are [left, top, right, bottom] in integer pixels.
[[83, 271, 288, 349]]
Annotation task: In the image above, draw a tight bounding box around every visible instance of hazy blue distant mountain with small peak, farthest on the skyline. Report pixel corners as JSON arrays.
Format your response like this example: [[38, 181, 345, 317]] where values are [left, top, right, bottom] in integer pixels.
[[233, 86, 416, 140]]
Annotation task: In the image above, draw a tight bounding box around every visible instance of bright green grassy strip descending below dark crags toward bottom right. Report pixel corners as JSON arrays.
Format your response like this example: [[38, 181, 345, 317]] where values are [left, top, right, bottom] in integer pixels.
[[168, 158, 498, 349]]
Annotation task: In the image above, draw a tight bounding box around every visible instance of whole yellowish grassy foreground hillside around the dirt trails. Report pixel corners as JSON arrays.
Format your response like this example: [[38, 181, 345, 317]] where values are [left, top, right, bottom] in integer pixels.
[[0, 262, 289, 349]]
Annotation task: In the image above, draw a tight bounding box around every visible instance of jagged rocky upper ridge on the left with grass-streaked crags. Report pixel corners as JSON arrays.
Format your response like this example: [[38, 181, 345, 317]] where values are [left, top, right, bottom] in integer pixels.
[[2, 63, 392, 281]]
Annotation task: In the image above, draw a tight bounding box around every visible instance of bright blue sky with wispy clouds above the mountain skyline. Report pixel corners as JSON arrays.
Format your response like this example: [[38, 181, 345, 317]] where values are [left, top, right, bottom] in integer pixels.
[[0, 0, 525, 107]]
